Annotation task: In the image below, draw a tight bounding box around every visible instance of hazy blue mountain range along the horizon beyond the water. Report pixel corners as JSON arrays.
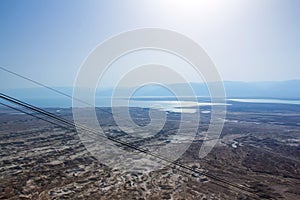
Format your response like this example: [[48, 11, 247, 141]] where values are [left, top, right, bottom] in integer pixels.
[[1, 80, 300, 100]]
